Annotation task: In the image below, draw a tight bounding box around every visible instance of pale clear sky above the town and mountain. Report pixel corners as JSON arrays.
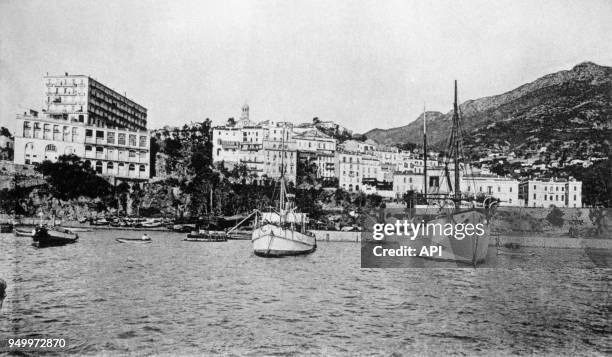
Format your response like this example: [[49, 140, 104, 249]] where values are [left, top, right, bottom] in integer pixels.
[[0, 0, 612, 132]]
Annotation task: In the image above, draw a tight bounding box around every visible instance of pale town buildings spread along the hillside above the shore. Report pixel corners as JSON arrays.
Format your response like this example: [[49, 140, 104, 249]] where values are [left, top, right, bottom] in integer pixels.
[[1, 73, 583, 216]]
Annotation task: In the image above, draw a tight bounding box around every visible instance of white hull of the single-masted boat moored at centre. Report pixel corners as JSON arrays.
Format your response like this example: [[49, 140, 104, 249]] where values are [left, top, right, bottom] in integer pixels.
[[251, 224, 317, 257]]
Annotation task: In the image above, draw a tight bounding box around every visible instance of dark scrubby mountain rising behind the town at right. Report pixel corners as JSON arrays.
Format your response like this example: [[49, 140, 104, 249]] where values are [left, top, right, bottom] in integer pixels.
[[365, 62, 612, 156]]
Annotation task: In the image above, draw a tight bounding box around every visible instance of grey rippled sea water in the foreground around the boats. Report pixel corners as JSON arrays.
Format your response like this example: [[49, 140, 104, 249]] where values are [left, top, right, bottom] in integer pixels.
[[0, 231, 612, 355]]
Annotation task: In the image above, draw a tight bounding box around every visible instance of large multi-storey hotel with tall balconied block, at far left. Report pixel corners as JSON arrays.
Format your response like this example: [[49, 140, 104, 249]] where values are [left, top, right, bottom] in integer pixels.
[[14, 74, 150, 180]]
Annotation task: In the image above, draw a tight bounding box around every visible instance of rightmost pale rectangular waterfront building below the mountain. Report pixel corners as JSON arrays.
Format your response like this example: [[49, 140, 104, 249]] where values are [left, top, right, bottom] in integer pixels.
[[519, 179, 582, 207]]
